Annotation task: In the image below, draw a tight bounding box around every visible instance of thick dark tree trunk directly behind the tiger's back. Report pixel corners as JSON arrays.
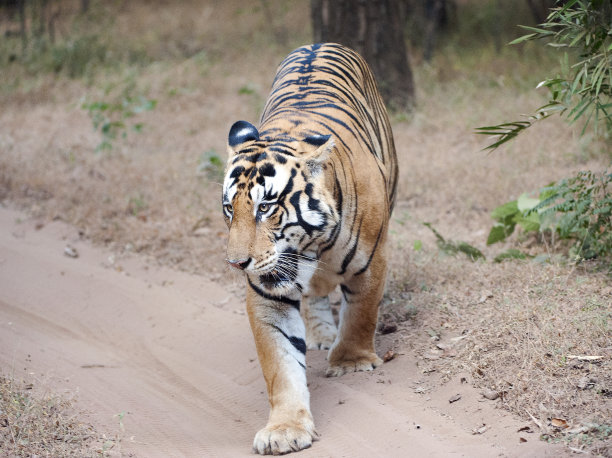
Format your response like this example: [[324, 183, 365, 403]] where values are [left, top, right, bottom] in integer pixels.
[[311, 0, 414, 111]]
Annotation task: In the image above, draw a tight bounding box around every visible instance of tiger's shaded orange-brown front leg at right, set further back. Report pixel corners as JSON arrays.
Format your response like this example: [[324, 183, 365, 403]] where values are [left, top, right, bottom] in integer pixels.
[[326, 250, 386, 377]]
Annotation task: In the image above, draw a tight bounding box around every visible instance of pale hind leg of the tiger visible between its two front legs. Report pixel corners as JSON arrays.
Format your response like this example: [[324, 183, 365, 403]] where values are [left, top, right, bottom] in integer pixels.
[[300, 296, 337, 350]]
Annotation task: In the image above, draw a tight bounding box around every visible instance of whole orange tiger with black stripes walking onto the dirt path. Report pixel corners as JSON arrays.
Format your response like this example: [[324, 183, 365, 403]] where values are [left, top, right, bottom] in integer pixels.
[[222, 43, 398, 455]]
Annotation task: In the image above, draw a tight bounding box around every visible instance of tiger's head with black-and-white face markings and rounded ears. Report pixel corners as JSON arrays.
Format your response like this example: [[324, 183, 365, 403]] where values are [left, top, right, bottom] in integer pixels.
[[222, 121, 338, 290]]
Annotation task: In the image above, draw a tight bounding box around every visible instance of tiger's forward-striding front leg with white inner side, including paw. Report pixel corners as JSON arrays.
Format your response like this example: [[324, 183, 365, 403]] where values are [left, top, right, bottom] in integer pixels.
[[247, 286, 317, 455]]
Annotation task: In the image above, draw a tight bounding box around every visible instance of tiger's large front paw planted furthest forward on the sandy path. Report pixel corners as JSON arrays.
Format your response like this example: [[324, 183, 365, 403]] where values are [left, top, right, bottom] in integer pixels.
[[253, 422, 318, 455]]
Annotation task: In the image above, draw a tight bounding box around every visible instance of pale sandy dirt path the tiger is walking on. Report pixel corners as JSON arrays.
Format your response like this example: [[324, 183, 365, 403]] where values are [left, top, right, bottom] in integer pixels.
[[0, 209, 563, 458]]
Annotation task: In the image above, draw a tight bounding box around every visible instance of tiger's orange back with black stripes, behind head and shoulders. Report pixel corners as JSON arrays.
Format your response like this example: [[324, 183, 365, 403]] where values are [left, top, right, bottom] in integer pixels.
[[260, 43, 398, 210]]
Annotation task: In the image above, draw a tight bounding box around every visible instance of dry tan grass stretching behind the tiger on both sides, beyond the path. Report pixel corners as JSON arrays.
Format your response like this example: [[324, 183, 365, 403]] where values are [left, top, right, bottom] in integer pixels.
[[0, 1, 612, 454]]
